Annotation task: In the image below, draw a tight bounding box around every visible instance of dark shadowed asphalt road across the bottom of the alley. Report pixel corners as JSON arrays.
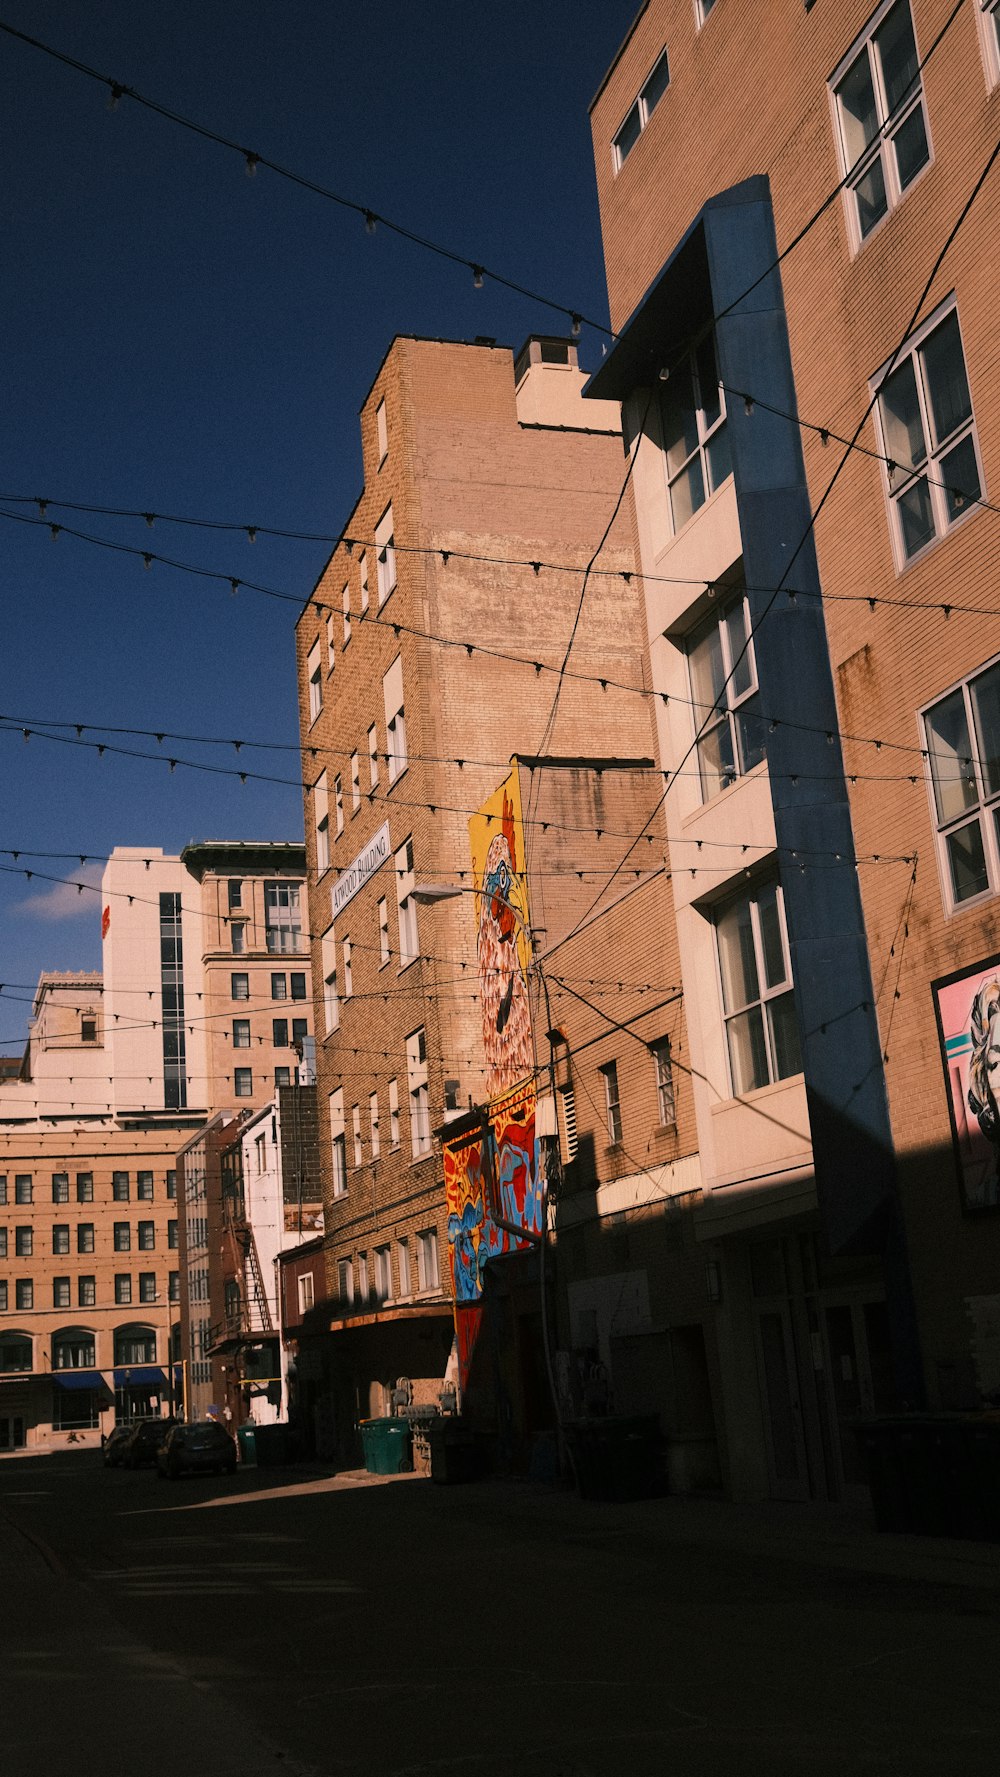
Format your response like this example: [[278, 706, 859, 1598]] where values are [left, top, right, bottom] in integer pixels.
[[0, 1454, 1000, 1777]]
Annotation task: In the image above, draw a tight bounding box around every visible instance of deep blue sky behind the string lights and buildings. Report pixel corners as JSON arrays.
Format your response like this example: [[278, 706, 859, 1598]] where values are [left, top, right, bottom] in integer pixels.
[[0, 0, 638, 1054]]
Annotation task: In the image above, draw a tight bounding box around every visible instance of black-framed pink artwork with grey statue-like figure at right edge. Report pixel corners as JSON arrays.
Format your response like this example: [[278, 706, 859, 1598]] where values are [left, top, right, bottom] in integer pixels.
[[931, 956, 1000, 1210]]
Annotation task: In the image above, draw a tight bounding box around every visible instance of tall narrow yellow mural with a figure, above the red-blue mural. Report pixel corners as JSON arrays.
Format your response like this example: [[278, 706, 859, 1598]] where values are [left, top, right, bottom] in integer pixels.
[[469, 766, 535, 1100]]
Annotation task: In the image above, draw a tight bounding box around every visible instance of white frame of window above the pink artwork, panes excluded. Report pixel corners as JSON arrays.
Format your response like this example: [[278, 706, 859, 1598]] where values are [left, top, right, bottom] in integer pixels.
[[920, 654, 1000, 913]]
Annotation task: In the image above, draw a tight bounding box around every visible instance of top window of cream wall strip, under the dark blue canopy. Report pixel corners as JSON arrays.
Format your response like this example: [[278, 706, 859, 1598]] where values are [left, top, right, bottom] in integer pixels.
[[659, 332, 732, 531]]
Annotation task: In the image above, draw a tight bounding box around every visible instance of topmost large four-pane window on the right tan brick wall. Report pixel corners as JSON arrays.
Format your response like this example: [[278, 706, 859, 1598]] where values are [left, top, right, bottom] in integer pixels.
[[831, 0, 931, 243]]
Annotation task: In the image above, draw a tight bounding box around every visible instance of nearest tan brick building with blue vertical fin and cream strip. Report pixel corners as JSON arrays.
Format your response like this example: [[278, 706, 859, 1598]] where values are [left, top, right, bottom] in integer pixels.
[[588, 0, 1000, 1498]]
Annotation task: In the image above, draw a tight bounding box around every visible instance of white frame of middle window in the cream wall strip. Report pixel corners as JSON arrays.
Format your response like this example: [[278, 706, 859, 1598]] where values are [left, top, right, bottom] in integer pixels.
[[686, 586, 766, 803]]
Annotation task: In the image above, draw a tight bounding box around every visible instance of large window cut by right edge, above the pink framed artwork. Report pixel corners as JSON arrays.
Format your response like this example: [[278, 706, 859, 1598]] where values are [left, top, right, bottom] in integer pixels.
[[924, 659, 1000, 906]]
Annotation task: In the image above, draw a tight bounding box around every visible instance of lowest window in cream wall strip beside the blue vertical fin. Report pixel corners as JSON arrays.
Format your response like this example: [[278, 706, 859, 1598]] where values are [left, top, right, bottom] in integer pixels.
[[716, 881, 801, 1095]]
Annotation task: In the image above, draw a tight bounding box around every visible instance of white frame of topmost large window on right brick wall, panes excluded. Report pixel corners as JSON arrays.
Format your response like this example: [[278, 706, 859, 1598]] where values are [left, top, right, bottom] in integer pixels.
[[829, 0, 934, 252]]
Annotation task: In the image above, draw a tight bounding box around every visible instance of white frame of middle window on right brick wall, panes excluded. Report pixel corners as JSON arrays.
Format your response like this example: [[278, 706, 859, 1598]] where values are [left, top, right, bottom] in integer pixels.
[[870, 295, 984, 572]]
